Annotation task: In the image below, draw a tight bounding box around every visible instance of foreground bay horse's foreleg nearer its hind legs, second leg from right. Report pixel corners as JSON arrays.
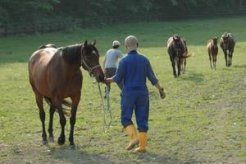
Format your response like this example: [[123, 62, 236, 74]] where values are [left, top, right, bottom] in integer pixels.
[[55, 101, 66, 145]]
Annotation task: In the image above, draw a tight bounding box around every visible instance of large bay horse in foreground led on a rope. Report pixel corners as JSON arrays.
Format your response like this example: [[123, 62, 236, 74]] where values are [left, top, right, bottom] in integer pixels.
[[28, 41, 104, 147]]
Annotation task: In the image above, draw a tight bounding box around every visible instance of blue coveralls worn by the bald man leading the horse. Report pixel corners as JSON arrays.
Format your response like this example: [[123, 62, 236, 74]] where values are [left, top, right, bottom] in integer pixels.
[[113, 51, 158, 132]]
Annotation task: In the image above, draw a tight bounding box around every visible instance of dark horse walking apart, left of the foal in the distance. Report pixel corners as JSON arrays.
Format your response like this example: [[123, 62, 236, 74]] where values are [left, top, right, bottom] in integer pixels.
[[167, 34, 189, 77]]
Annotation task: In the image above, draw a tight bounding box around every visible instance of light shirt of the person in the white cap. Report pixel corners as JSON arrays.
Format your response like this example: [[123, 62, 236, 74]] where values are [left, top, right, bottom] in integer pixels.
[[104, 48, 123, 68]]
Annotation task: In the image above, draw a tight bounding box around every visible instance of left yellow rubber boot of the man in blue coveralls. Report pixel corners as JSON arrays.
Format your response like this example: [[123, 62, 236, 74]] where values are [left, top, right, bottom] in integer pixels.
[[125, 125, 138, 150]]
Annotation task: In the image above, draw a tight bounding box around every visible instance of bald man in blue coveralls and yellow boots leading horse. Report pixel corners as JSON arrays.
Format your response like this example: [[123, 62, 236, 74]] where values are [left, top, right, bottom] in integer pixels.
[[105, 35, 166, 152]]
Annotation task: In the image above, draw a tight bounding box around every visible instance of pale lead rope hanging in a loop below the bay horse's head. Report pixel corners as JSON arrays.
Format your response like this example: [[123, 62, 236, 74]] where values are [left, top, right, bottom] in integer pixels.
[[97, 83, 112, 129]]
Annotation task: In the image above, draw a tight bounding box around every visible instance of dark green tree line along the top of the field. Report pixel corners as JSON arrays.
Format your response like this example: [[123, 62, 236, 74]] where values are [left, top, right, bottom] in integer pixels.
[[0, 0, 246, 31]]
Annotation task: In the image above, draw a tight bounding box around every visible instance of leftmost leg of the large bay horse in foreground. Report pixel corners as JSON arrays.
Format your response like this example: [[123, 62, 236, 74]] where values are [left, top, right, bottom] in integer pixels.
[[36, 94, 47, 145]]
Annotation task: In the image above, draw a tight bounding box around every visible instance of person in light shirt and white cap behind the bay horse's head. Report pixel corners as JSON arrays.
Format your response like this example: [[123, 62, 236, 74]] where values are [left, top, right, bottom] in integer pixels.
[[102, 40, 123, 92]]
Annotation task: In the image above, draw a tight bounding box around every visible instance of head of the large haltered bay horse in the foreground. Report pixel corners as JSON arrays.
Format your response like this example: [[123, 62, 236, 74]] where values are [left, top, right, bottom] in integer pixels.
[[81, 41, 104, 82]]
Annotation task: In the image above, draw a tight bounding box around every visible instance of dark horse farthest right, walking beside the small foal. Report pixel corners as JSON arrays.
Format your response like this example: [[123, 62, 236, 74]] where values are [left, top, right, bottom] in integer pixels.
[[220, 32, 236, 67]]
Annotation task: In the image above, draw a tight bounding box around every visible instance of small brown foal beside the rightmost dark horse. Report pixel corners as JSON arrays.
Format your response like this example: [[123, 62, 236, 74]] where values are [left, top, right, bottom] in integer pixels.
[[207, 37, 218, 69]]
